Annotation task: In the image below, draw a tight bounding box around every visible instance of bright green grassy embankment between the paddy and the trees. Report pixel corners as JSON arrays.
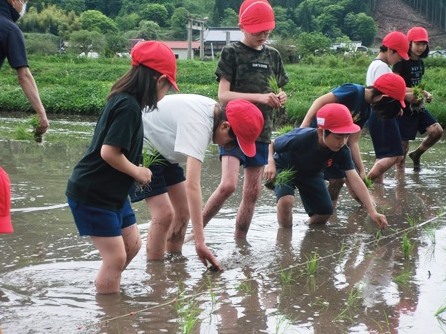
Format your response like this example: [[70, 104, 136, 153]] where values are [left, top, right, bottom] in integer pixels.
[[0, 55, 446, 125]]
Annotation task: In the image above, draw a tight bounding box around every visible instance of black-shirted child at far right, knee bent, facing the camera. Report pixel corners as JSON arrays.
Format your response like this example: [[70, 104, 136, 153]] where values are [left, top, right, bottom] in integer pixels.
[[393, 27, 443, 171]]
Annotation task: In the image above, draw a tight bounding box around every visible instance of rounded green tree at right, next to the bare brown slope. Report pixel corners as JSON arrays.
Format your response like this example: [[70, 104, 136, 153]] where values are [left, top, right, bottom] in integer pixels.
[[344, 13, 377, 45]]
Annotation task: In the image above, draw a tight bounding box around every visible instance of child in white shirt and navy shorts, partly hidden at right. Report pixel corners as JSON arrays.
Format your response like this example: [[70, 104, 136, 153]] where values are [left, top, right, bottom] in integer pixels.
[[366, 31, 409, 183]]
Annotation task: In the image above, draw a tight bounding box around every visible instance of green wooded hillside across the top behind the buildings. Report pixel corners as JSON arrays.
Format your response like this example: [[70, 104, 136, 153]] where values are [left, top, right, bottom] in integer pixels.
[[15, 0, 446, 59]]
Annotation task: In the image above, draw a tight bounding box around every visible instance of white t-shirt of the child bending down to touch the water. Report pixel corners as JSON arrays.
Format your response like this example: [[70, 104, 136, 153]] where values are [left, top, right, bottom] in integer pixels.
[[142, 94, 217, 163]]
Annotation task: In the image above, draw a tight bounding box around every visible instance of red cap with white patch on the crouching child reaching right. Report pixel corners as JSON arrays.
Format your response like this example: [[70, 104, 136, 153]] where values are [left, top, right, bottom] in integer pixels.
[[316, 103, 361, 133]]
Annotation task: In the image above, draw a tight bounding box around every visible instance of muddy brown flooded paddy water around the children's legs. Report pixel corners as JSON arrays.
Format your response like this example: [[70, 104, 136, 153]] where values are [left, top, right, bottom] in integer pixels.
[[0, 119, 446, 334]]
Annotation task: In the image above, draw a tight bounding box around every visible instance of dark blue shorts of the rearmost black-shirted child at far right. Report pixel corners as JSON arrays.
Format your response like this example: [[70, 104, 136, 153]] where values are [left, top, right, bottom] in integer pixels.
[[397, 109, 437, 140]]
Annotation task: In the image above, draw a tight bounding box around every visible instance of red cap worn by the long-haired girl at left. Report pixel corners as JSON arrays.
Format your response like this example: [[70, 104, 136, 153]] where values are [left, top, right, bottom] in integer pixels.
[[130, 41, 178, 91]]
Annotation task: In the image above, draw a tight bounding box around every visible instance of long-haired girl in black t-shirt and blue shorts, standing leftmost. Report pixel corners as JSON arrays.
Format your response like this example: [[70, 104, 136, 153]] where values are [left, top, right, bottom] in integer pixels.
[[66, 41, 177, 293]]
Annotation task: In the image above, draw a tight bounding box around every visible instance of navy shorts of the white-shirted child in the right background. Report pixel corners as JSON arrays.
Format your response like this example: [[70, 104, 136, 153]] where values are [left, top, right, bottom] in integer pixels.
[[368, 111, 404, 159]]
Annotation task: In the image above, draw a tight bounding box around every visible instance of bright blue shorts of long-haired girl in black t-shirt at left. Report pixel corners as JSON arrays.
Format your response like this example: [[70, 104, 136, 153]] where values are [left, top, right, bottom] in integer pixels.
[[68, 198, 136, 237]]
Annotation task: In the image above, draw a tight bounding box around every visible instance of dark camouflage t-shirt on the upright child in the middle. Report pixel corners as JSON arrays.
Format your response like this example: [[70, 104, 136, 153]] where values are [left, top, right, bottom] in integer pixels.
[[215, 42, 288, 143]]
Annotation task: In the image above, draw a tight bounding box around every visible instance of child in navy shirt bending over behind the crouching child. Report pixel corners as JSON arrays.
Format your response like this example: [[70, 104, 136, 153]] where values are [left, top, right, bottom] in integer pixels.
[[290, 73, 406, 208]]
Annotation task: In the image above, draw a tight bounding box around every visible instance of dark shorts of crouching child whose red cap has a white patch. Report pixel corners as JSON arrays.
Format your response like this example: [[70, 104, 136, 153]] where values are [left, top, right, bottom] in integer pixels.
[[274, 170, 333, 217]]
